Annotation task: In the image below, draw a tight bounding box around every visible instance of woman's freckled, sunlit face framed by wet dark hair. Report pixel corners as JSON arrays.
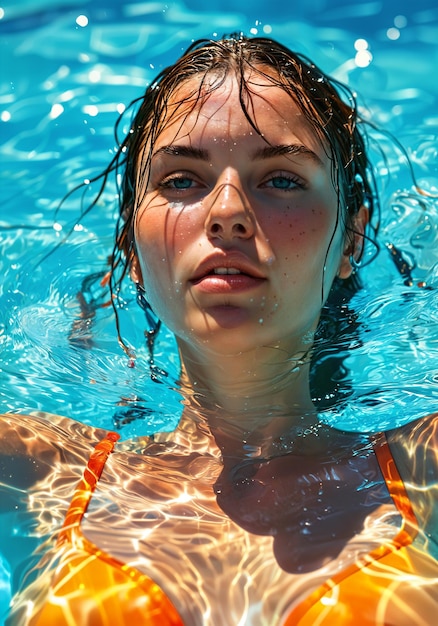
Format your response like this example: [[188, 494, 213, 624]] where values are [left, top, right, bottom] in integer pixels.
[[133, 74, 350, 354]]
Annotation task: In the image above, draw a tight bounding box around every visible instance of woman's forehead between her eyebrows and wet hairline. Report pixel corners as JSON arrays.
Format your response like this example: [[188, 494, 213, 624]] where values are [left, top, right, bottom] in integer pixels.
[[157, 70, 325, 155]]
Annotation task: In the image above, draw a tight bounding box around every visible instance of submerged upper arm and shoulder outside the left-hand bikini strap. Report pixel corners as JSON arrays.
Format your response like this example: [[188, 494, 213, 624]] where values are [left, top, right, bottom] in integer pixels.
[[0, 414, 100, 584]]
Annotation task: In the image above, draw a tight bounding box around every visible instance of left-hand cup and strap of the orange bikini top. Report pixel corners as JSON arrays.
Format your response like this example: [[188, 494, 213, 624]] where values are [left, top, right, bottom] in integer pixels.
[[29, 432, 184, 626]]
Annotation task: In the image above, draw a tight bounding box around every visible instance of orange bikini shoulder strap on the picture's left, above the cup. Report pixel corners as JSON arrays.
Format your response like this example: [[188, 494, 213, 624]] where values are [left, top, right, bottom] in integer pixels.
[[58, 432, 120, 543]]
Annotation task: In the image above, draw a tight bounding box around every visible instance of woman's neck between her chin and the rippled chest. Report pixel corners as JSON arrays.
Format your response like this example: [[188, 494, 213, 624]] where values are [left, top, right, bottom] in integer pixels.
[[176, 338, 318, 445]]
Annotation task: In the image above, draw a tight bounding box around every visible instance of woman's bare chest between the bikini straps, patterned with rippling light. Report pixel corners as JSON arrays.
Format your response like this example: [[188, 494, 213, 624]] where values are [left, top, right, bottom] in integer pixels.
[[82, 450, 399, 626]]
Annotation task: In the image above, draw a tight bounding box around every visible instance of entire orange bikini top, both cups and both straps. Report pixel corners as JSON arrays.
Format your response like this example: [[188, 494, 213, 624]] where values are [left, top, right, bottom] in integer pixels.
[[29, 433, 428, 626]]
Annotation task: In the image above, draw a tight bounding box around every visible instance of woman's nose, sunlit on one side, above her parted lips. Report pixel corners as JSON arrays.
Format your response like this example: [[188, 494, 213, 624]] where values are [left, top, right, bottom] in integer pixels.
[[205, 181, 255, 240]]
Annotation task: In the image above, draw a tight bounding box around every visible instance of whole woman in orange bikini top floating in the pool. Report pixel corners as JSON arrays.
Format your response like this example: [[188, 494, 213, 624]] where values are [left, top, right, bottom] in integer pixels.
[[1, 36, 438, 626]]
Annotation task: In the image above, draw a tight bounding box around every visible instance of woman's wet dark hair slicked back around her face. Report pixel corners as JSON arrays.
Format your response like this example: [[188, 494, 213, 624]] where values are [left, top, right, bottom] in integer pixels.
[[109, 34, 377, 293]]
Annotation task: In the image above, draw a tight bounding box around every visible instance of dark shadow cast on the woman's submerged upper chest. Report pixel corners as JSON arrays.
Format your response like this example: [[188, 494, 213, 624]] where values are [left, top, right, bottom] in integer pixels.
[[215, 434, 391, 573]]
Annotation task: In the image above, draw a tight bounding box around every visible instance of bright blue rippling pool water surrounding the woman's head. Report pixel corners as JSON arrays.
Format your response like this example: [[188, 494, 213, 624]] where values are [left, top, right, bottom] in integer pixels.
[[0, 0, 438, 616]]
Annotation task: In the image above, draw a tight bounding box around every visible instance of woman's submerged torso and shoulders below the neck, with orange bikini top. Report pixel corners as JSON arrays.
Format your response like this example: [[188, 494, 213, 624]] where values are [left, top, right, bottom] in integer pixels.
[[1, 415, 438, 626]]
